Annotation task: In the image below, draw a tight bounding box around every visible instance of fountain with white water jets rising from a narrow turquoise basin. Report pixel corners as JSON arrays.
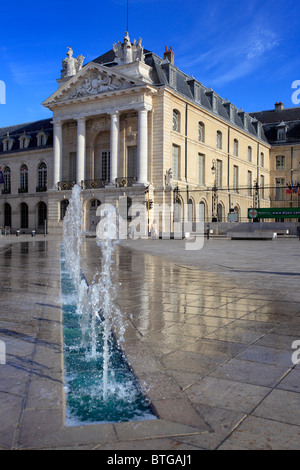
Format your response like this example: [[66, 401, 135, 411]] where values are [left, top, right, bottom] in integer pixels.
[[61, 185, 155, 425]]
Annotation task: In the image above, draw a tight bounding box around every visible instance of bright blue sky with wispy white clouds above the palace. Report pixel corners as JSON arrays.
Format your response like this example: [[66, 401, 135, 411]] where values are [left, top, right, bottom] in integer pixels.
[[0, 0, 300, 127]]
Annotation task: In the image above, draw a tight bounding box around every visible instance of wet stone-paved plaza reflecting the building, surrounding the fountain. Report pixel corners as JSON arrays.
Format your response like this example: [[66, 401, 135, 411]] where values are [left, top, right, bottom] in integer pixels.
[[0, 236, 300, 451]]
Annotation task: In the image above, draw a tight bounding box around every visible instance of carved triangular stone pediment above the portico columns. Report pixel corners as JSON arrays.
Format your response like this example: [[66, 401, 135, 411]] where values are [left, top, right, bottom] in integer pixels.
[[42, 62, 146, 107]]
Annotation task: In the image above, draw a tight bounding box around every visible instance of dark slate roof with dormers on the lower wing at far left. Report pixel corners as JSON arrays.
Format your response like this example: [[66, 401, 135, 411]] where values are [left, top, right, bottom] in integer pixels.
[[0, 118, 53, 154]]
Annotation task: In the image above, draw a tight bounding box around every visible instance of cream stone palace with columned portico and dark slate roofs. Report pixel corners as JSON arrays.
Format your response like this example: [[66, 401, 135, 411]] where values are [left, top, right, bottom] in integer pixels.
[[0, 33, 300, 233]]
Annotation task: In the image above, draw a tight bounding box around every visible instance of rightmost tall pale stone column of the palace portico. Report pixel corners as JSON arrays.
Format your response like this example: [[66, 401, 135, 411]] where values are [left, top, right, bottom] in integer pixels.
[[137, 108, 148, 185]]
